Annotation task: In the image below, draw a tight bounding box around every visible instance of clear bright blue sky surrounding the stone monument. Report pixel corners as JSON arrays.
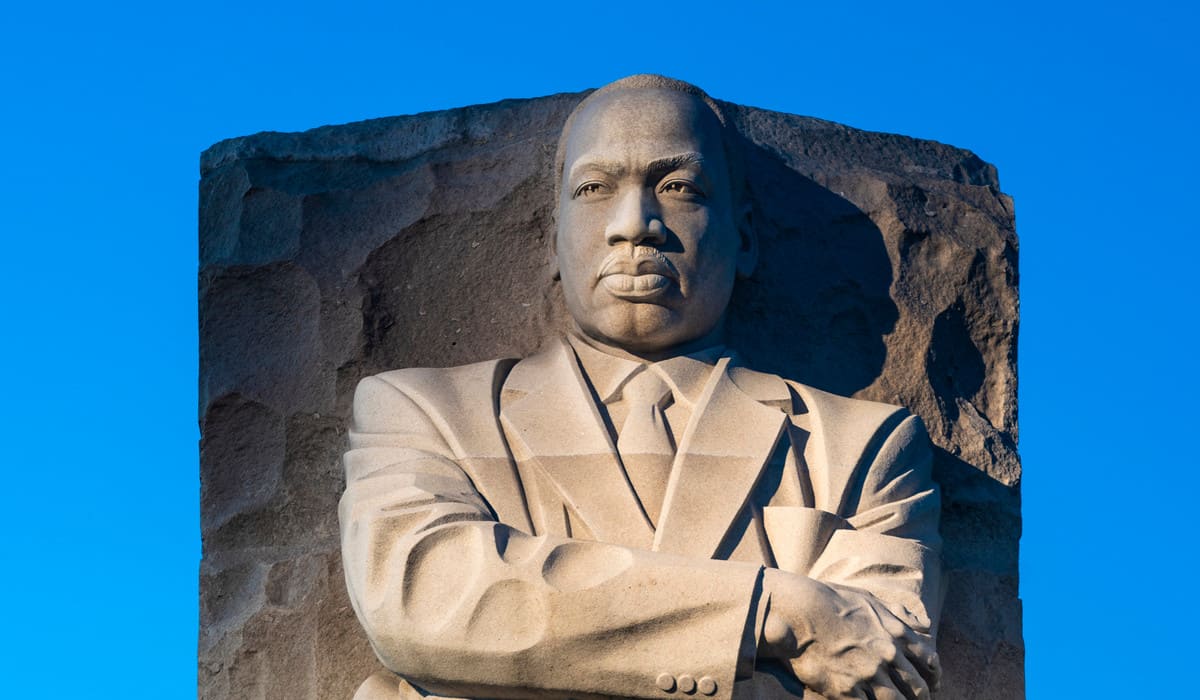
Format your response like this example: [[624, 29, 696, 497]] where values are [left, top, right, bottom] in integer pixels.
[[0, 0, 1200, 700]]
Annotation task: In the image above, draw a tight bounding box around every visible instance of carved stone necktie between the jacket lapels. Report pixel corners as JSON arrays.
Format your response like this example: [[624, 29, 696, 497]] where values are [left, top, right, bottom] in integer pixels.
[[617, 367, 674, 526]]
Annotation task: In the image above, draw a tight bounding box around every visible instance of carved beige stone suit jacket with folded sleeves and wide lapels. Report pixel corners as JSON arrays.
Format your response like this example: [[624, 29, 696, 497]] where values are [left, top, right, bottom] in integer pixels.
[[340, 342, 940, 700]]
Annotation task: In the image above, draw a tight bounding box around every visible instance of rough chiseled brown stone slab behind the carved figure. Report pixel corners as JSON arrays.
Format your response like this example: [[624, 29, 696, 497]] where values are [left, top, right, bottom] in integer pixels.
[[199, 90, 1024, 700]]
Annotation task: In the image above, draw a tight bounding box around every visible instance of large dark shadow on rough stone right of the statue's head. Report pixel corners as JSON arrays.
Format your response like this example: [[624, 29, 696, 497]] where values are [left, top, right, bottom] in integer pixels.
[[730, 143, 898, 396]]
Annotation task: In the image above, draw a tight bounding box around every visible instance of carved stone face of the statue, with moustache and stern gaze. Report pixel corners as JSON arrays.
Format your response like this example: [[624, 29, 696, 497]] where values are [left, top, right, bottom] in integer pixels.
[[556, 89, 754, 353]]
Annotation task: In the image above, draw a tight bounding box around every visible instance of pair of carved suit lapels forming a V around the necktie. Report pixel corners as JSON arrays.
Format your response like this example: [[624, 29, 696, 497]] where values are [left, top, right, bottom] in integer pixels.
[[500, 341, 790, 558]]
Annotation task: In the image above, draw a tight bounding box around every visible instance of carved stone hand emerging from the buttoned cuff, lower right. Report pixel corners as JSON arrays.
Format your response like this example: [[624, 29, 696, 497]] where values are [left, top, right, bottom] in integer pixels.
[[758, 569, 941, 700]]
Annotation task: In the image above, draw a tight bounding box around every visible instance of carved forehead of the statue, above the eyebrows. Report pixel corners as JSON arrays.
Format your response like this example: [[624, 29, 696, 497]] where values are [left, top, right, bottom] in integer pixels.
[[564, 89, 725, 174]]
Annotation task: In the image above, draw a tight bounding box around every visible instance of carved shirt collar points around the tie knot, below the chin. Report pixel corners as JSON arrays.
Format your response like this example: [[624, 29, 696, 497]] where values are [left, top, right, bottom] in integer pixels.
[[566, 333, 725, 405]]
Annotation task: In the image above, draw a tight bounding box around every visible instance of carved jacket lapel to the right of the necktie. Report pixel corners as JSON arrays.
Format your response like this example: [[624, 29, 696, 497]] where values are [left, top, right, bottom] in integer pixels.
[[654, 358, 787, 558]]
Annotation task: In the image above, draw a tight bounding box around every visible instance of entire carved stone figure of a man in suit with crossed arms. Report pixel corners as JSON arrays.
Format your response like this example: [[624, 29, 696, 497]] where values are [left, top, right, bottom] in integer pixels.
[[340, 76, 941, 700]]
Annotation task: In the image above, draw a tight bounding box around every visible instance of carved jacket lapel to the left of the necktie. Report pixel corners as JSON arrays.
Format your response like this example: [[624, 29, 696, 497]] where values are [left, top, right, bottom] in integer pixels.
[[500, 341, 654, 549]]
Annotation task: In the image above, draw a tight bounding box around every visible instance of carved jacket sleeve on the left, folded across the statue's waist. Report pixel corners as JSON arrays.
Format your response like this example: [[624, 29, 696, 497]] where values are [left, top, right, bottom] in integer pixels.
[[340, 372, 761, 699]]
